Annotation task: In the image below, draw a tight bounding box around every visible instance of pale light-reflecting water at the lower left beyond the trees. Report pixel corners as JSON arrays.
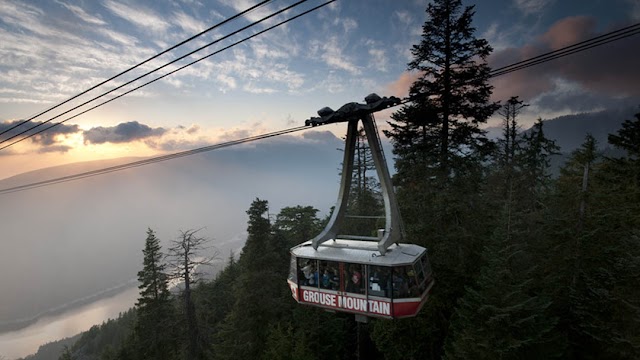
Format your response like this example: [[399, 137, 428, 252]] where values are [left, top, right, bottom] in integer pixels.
[[0, 286, 138, 359]]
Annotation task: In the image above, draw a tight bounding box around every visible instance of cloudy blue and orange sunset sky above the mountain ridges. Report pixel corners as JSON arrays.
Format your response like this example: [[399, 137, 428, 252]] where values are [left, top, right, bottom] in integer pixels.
[[0, 0, 640, 178]]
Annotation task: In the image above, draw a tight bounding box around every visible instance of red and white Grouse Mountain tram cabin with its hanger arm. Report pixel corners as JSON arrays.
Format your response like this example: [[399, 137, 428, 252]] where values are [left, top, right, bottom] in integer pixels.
[[287, 94, 434, 322]]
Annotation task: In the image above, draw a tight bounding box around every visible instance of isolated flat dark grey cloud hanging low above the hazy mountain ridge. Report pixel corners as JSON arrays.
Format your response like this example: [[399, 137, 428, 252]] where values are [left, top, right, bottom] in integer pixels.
[[82, 121, 167, 144]]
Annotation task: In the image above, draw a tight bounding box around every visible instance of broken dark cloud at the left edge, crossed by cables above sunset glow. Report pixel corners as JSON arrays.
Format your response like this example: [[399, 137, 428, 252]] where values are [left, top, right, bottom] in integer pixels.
[[0, 120, 80, 148]]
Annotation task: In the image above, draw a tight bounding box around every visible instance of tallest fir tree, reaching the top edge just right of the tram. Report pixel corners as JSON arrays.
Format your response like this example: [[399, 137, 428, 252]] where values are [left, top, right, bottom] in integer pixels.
[[380, 0, 499, 357]]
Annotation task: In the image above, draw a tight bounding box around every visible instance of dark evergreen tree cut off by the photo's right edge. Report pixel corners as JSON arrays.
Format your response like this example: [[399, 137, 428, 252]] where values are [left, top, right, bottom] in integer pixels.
[[570, 116, 640, 359]]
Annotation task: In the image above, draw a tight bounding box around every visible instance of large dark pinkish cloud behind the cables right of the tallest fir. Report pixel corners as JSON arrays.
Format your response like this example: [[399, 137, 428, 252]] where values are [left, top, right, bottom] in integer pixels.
[[489, 16, 640, 105]]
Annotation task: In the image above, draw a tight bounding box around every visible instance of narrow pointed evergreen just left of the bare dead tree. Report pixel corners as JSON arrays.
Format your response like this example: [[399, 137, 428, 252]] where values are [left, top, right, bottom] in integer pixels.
[[135, 229, 175, 359]]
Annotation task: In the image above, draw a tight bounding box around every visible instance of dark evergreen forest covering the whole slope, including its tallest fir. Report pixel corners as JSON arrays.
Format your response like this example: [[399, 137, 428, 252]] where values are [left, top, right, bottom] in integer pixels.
[[46, 0, 640, 360]]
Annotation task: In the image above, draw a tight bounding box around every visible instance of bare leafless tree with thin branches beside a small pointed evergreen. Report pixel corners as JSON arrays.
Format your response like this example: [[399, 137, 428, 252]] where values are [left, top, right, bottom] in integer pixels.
[[167, 229, 218, 360]]
